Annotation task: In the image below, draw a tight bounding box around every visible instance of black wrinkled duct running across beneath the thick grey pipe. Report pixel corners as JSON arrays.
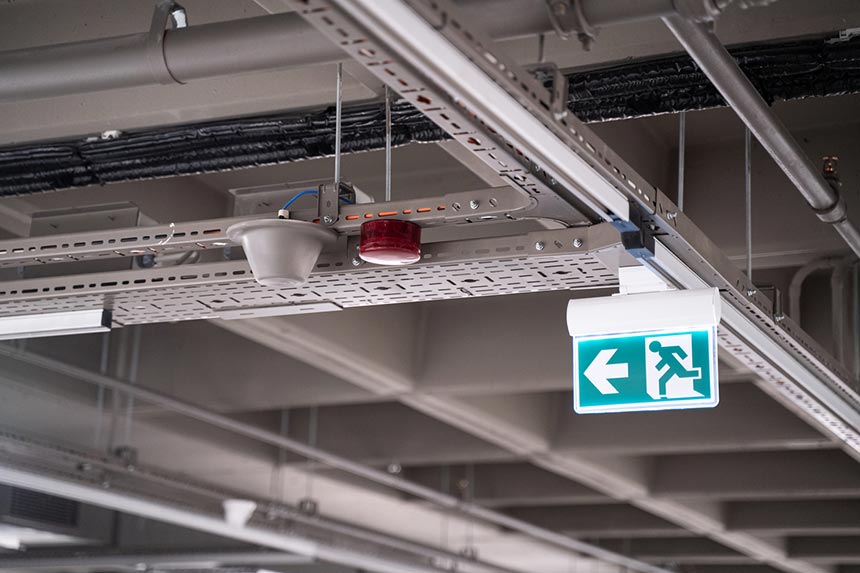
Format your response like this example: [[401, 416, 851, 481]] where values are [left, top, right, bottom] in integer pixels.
[[0, 38, 860, 197]]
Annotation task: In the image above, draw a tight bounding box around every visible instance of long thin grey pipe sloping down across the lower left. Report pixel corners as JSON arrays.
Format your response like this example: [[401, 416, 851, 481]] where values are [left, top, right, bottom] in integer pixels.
[[0, 346, 670, 573]]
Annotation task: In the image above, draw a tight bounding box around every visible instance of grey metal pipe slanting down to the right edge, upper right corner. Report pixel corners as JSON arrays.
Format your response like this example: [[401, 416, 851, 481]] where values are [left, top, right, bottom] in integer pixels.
[[663, 16, 860, 256]]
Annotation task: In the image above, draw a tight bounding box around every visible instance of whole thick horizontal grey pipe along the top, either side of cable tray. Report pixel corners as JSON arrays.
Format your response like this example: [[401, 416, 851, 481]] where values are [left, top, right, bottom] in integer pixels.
[[0, 0, 684, 102]]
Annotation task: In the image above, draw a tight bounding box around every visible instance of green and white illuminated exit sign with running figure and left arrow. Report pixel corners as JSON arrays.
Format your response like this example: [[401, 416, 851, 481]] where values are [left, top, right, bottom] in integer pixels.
[[567, 289, 720, 414]]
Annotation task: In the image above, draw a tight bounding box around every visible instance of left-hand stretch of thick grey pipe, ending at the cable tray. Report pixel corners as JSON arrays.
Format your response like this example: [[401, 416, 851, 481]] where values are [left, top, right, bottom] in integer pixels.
[[0, 14, 345, 102]]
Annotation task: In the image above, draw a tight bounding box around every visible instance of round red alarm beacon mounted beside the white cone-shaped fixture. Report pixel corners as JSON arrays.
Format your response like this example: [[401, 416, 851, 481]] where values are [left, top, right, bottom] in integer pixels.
[[358, 219, 421, 266]]
